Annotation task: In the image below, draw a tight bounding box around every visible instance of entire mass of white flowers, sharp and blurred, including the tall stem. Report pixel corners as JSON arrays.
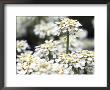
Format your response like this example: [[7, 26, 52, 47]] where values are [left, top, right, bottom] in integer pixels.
[[16, 17, 94, 75]]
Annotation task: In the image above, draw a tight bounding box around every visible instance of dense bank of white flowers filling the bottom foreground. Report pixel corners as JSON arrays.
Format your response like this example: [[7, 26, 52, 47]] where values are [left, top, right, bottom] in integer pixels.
[[17, 46, 94, 75]]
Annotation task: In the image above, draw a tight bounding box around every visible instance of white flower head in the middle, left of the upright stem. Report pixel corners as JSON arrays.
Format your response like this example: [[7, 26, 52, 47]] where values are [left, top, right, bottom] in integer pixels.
[[33, 40, 58, 61]]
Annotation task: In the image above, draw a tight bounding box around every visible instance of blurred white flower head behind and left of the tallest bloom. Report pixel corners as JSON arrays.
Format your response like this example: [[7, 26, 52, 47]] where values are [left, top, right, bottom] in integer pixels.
[[34, 20, 60, 38]]
